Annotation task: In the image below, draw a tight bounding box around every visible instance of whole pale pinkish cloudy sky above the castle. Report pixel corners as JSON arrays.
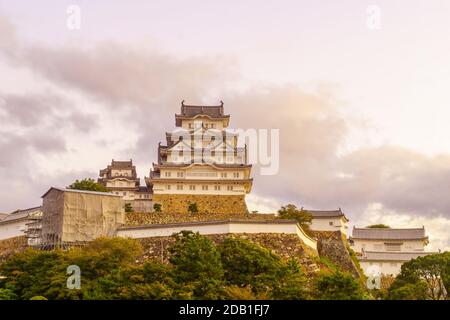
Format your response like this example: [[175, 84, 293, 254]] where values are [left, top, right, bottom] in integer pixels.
[[0, 0, 450, 250]]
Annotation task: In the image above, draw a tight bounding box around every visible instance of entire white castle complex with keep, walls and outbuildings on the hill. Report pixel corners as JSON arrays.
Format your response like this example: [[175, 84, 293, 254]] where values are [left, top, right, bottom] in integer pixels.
[[0, 101, 440, 275]]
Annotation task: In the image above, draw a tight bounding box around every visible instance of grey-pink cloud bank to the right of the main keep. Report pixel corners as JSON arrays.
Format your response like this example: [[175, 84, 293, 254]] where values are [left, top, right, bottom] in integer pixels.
[[227, 86, 450, 222]]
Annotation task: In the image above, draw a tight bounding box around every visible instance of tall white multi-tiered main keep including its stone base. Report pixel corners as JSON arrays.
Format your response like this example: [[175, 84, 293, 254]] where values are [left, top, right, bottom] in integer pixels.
[[146, 102, 253, 213]]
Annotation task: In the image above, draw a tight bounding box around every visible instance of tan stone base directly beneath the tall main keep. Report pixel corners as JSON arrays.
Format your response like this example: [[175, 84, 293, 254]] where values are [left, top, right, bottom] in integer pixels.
[[153, 194, 248, 214]]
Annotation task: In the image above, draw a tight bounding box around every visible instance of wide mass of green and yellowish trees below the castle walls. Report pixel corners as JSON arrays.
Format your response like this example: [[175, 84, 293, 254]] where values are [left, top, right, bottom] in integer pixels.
[[0, 232, 386, 300]]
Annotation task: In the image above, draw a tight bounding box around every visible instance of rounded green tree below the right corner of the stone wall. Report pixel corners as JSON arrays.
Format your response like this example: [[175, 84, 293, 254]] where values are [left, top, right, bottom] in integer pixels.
[[315, 271, 366, 300]]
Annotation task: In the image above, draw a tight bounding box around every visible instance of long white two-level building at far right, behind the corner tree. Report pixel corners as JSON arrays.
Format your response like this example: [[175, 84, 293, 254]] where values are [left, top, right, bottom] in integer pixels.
[[349, 227, 434, 276]]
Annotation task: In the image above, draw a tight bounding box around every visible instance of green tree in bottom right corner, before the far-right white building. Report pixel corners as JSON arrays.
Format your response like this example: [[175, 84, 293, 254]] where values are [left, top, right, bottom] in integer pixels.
[[389, 252, 450, 300]]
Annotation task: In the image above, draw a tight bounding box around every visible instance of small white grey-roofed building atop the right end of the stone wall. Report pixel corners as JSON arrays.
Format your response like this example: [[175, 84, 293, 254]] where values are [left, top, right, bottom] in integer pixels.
[[308, 208, 348, 235]]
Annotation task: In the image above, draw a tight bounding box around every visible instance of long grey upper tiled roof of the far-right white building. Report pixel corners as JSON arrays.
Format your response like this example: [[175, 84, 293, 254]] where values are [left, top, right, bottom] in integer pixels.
[[351, 227, 427, 240]]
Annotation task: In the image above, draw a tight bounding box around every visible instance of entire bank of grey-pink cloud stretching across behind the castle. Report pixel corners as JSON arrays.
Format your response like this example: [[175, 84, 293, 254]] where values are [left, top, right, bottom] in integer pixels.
[[0, 14, 450, 250]]
